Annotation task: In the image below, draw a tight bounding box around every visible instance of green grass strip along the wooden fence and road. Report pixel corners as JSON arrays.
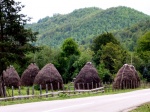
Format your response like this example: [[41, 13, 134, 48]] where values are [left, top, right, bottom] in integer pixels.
[[0, 87, 142, 106]]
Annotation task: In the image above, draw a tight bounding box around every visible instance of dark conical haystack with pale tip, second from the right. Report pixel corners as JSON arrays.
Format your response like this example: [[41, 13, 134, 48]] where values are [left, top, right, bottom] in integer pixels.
[[74, 62, 101, 89]]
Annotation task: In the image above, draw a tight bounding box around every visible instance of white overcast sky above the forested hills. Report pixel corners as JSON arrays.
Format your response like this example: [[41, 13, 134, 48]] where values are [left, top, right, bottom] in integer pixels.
[[15, 0, 150, 22]]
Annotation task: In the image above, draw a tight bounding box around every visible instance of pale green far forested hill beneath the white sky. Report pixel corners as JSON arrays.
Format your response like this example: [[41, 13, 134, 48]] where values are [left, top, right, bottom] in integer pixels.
[[27, 6, 150, 47]]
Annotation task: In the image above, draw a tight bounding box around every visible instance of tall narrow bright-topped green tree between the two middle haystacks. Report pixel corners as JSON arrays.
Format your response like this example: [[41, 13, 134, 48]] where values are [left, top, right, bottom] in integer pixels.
[[56, 38, 80, 83]]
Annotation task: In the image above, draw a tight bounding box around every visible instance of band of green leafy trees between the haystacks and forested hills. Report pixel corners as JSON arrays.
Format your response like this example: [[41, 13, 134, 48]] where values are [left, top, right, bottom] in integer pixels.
[[27, 32, 150, 83]]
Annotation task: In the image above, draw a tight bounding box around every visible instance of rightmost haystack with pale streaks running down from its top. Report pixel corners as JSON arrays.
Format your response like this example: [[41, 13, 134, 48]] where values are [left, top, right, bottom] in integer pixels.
[[113, 64, 140, 89]]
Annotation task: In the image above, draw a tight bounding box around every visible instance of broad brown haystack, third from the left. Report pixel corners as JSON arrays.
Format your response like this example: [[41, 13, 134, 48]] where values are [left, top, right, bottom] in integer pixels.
[[34, 63, 63, 90]]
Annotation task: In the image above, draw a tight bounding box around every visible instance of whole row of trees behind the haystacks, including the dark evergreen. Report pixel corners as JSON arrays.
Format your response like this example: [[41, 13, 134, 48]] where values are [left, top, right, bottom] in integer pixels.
[[0, 0, 150, 95]]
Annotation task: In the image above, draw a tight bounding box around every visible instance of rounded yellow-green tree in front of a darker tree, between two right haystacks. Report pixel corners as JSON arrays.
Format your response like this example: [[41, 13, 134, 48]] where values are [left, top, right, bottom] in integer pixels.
[[101, 42, 127, 74]]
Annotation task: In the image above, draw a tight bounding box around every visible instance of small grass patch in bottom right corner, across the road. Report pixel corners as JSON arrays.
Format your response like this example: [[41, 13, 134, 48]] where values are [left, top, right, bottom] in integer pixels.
[[131, 102, 150, 112]]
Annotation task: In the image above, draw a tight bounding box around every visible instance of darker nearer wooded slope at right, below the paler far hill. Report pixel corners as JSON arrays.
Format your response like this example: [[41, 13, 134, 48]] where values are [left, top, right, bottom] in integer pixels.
[[114, 20, 150, 51]]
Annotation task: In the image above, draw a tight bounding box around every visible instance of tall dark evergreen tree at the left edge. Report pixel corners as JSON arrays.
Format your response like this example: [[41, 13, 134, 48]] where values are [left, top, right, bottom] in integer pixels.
[[0, 0, 37, 95]]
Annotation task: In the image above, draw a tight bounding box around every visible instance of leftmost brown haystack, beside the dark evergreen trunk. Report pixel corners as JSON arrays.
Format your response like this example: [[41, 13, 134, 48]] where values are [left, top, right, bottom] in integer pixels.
[[3, 66, 21, 88]]
